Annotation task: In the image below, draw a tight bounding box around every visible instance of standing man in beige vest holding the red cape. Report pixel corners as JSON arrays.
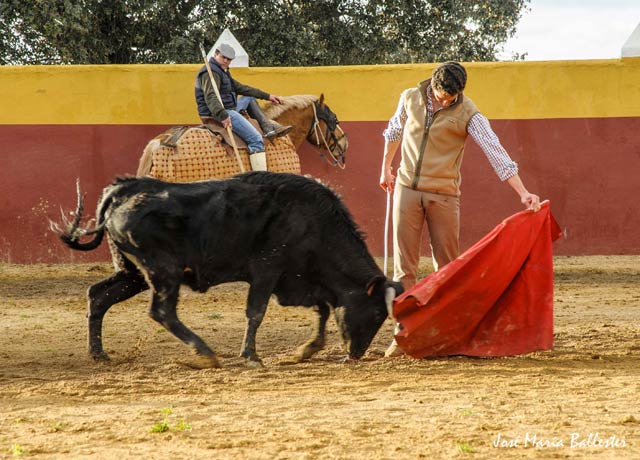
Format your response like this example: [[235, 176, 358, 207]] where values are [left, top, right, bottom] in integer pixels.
[[380, 62, 540, 356]]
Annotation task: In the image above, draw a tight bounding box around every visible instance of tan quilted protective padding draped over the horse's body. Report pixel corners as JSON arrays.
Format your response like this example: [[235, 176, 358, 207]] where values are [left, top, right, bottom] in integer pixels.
[[143, 119, 300, 182]]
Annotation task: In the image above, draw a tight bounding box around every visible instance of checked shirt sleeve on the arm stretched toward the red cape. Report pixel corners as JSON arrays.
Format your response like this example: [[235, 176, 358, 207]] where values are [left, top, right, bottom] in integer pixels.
[[467, 113, 518, 181]]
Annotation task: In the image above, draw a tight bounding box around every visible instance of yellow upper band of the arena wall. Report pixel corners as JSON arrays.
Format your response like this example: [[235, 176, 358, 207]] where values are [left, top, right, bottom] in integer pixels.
[[0, 58, 640, 125]]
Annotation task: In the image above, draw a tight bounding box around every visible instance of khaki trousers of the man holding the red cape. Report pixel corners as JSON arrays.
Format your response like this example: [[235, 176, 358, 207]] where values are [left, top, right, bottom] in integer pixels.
[[393, 183, 460, 289]]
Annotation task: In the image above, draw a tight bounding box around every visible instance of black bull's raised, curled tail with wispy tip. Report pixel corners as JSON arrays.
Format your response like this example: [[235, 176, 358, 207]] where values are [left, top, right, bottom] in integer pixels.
[[49, 180, 111, 251]]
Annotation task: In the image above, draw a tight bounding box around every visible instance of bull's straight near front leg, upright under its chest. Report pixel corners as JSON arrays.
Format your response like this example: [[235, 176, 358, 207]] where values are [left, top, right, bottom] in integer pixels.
[[240, 280, 273, 367]]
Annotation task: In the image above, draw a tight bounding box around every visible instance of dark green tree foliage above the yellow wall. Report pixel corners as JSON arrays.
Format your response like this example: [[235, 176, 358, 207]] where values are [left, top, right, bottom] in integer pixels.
[[0, 0, 529, 66]]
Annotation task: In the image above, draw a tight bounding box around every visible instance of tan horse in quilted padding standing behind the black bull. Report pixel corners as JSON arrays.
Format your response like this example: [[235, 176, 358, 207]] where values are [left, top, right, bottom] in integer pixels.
[[136, 94, 349, 182]]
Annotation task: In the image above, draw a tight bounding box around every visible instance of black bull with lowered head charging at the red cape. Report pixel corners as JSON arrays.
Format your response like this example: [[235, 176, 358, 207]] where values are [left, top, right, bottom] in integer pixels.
[[53, 172, 402, 367]]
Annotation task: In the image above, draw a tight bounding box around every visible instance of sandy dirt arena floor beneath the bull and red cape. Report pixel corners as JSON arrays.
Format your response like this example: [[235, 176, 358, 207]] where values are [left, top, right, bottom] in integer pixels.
[[0, 256, 640, 460]]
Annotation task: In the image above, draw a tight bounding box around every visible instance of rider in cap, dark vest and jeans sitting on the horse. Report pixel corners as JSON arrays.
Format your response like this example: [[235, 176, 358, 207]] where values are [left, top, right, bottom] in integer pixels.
[[195, 43, 292, 171]]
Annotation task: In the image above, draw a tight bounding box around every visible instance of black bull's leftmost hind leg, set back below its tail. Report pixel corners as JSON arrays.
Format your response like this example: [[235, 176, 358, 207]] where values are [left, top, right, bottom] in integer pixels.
[[87, 271, 149, 361]]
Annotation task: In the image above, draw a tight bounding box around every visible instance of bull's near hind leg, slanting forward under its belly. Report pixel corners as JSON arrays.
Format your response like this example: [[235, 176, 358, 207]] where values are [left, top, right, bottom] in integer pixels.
[[149, 281, 221, 369]]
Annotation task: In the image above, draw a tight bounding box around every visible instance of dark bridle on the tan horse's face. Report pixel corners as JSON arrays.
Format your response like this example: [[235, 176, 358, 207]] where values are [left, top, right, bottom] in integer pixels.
[[307, 101, 348, 169]]
